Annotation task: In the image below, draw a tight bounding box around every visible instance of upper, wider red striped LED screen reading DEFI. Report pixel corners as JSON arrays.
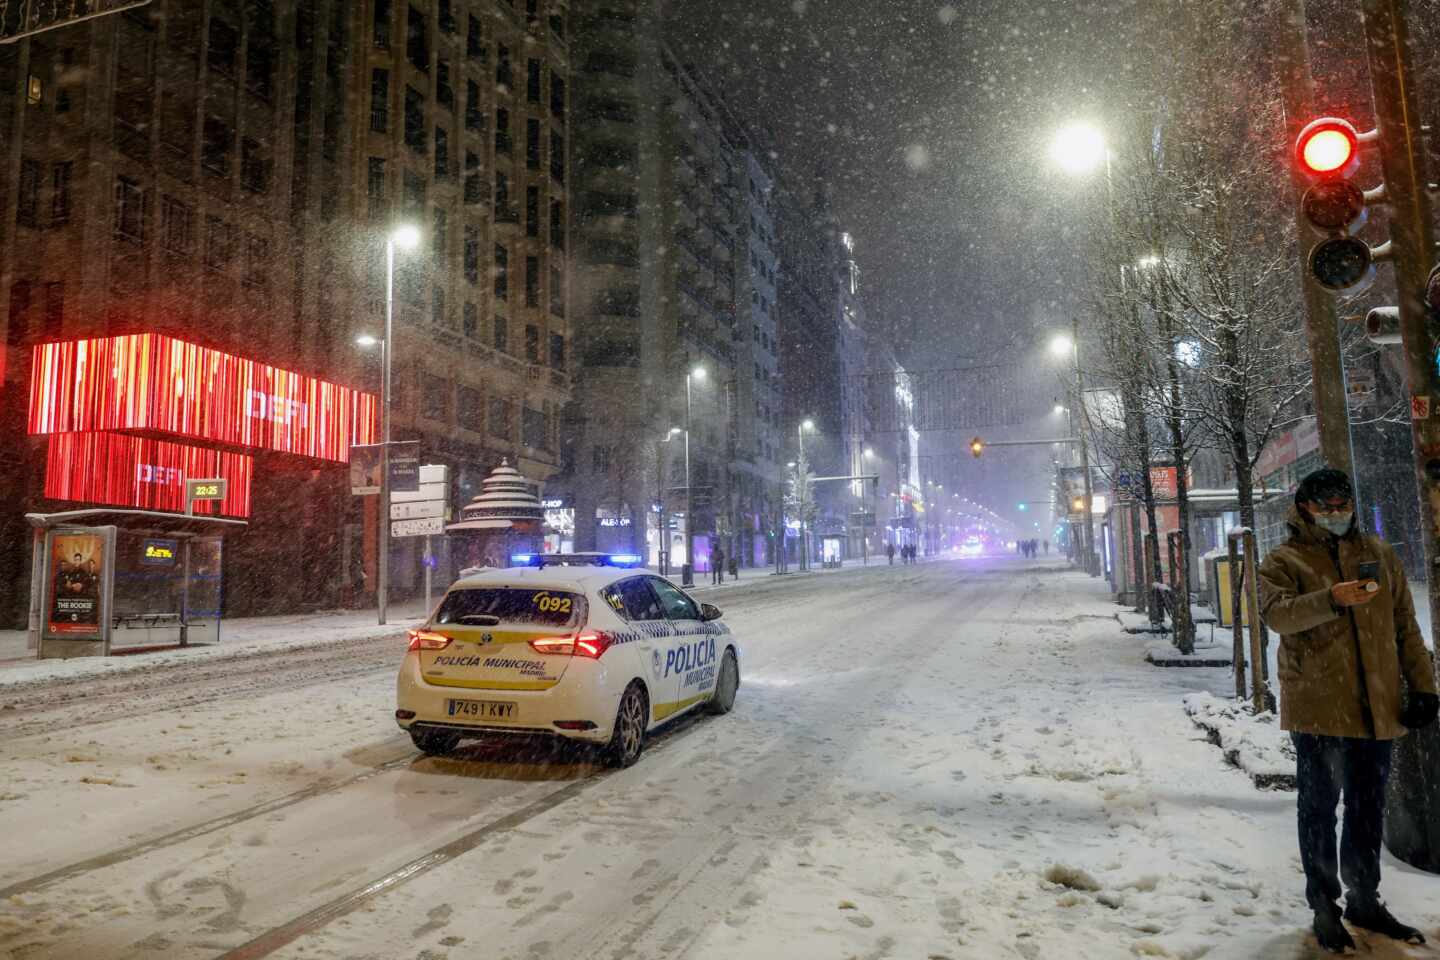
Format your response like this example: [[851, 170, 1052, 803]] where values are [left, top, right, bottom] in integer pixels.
[[29, 334, 377, 460]]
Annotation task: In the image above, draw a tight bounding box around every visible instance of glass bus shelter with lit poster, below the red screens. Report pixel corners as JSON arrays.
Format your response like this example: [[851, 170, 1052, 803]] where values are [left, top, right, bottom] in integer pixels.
[[26, 508, 246, 659]]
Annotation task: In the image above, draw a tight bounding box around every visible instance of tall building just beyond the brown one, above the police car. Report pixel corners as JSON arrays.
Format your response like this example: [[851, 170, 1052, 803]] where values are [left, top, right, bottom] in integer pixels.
[[547, 0, 778, 570]]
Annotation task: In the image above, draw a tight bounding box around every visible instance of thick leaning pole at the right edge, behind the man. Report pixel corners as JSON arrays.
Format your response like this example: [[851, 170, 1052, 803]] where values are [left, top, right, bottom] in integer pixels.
[[1361, 0, 1440, 871]]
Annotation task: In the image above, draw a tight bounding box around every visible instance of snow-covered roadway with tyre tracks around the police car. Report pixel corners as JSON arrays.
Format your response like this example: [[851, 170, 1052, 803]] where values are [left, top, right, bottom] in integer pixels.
[[0, 558, 1440, 960]]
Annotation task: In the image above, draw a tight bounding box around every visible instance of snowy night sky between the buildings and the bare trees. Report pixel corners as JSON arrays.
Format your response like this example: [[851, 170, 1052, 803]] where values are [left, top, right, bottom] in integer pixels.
[[665, 0, 1139, 526]]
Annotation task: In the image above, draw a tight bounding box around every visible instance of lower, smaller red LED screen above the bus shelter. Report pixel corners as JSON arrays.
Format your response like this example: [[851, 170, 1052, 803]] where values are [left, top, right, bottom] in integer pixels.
[[45, 433, 255, 517]]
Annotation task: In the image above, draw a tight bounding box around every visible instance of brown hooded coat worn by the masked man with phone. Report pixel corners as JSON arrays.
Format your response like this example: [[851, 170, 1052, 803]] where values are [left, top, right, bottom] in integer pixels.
[[1260, 507, 1436, 740]]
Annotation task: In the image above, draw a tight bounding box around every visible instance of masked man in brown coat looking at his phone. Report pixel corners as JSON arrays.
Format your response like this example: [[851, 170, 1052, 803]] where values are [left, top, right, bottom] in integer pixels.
[[1260, 469, 1440, 953]]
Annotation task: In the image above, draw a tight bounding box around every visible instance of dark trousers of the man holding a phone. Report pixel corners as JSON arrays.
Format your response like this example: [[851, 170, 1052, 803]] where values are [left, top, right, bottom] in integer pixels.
[[1290, 733, 1391, 910]]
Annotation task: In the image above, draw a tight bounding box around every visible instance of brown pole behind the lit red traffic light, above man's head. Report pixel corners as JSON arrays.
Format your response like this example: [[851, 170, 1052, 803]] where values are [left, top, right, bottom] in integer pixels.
[[1279, 0, 1353, 478]]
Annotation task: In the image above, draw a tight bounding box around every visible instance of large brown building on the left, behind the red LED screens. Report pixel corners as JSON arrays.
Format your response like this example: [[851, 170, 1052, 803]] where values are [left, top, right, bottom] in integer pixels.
[[0, 0, 569, 620]]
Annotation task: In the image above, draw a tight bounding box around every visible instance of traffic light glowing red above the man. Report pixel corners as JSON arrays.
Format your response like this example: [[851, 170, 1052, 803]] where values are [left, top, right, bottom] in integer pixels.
[[1295, 117, 1375, 294]]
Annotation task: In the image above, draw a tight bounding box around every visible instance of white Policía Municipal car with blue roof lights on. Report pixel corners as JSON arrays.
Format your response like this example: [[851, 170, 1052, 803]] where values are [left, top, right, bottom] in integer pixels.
[[395, 554, 740, 767]]
